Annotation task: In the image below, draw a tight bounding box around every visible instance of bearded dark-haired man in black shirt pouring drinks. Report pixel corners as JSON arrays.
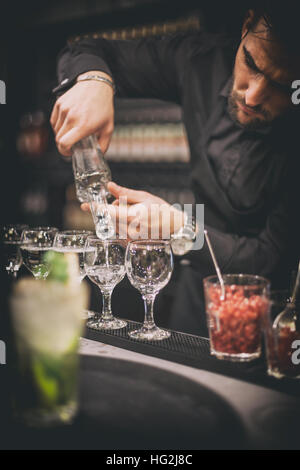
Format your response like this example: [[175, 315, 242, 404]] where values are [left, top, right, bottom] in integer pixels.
[[51, 4, 300, 334]]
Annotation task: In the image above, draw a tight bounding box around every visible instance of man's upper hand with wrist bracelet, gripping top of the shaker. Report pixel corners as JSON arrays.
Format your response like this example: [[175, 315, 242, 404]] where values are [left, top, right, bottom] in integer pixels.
[[50, 71, 114, 156]]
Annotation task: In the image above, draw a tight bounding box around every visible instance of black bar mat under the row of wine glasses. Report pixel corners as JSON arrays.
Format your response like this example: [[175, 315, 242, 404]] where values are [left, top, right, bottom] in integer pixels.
[[83, 320, 300, 397]]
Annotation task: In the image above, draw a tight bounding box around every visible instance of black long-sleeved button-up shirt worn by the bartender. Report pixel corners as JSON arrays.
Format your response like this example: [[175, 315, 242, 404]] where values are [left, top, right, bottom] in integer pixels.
[[55, 33, 300, 287]]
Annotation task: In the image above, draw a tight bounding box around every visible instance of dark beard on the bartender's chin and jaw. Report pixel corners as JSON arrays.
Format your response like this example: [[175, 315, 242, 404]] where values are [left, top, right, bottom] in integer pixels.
[[228, 89, 272, 131]]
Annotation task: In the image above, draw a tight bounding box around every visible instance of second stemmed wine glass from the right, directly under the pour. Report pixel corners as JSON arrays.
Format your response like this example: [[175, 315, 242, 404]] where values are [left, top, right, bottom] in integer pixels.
[[84, 236, 127, 330]]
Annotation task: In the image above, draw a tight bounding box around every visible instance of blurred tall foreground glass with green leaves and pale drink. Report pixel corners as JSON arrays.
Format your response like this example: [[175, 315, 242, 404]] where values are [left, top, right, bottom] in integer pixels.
[[10, 277, 88, 427]]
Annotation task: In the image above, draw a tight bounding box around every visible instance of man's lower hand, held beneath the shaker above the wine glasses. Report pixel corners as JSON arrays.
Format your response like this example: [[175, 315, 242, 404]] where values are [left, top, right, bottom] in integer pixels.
[[81, 182, 184, 239]]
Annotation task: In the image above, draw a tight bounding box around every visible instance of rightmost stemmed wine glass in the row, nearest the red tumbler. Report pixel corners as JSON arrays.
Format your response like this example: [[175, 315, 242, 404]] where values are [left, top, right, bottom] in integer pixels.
[[125, 240, 173, 340]]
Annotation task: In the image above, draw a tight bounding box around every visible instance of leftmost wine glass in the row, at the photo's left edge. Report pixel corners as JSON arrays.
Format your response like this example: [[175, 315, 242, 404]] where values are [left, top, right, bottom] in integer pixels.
[[1, 224, 28, 278]]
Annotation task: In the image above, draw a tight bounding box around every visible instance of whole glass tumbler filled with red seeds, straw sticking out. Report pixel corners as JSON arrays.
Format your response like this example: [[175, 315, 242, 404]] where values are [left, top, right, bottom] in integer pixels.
[[203, 274, 270, 362]]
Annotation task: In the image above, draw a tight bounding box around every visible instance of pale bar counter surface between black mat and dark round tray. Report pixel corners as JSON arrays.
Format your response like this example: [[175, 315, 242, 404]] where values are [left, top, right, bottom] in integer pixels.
[[80, 328, 300, 449]]
